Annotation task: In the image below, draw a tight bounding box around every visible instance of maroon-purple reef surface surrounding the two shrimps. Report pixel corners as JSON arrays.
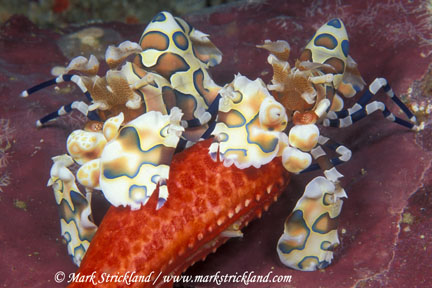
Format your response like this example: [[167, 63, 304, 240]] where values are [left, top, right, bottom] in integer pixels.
[[0, 0, 432, 288]]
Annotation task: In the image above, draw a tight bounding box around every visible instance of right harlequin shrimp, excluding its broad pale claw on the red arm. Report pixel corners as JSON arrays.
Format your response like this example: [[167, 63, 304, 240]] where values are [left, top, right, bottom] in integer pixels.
[[258, 19, 419, 271]]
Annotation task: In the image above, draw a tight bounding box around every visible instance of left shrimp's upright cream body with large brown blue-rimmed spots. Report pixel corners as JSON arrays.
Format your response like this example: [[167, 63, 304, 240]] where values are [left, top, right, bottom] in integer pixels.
[[134, 12, 222, 141]]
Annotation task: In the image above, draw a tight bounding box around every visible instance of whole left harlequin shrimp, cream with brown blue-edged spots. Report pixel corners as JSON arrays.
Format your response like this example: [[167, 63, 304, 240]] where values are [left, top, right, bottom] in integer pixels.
[[21, 12, 222, 265]]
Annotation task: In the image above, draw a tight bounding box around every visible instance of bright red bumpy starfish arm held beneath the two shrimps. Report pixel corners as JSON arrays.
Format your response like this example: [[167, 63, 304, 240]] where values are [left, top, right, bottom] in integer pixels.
[[68, 139, 290, 288]]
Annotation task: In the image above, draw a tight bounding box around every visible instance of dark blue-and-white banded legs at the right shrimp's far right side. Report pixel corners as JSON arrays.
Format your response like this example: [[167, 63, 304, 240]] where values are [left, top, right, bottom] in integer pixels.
[[323, 78, 417, 130]]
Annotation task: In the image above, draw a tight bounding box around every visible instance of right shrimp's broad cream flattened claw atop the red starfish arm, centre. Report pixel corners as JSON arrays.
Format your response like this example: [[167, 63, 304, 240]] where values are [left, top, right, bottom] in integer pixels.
[[209, 75, 288, 169]]
